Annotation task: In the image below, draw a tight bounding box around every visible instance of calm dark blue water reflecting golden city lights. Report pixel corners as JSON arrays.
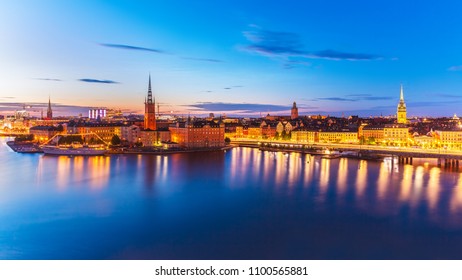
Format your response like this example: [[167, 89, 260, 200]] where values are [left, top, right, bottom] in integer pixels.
[[0, 138, 462, 259]]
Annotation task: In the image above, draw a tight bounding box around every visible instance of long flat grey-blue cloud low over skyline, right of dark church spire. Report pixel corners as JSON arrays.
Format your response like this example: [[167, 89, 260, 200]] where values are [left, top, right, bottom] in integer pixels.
[[187, 102, 292, 113]]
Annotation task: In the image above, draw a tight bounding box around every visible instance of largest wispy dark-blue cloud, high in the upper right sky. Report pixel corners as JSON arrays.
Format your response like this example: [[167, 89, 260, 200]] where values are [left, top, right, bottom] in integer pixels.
[[243, 25, 383, 69]]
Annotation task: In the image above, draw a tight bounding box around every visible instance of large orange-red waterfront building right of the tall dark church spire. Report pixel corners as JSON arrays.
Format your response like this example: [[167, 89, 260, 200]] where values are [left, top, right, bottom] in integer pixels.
[[169, 120, 225, 149]]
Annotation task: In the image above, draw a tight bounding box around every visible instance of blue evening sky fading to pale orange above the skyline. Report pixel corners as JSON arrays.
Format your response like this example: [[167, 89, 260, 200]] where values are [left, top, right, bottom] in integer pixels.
[[0, 0, 462, 117]]
